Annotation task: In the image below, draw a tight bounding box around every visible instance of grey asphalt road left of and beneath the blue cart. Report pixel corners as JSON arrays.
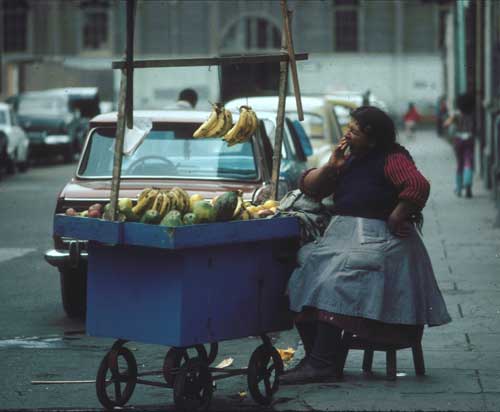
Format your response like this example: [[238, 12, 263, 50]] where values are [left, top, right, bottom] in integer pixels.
[[0, 159, 297, 410]]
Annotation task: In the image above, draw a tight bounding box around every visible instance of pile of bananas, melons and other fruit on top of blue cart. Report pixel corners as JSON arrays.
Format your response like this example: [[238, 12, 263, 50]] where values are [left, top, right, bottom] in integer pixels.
[[66, 187, 279, 227]]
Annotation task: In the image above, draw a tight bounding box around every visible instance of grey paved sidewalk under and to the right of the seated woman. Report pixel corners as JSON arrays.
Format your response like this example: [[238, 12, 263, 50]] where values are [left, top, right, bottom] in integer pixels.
[[266, 131, 500, 411]]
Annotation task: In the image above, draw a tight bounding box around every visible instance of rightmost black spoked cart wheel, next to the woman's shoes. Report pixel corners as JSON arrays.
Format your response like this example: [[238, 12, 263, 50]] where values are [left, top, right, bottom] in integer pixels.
[[247, 345, 283, 405]]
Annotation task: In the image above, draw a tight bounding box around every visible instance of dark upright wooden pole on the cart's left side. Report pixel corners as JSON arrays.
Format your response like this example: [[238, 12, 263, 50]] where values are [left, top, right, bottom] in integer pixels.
[[110, 0, 136, 220]]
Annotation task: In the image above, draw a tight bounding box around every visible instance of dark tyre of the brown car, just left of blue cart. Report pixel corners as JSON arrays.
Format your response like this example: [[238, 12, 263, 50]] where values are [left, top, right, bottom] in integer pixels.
[[59, 268, 87, 318]]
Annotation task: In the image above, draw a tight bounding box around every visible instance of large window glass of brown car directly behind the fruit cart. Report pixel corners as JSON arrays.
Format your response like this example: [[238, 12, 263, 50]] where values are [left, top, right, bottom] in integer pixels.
[[78, 123, 259, 181]]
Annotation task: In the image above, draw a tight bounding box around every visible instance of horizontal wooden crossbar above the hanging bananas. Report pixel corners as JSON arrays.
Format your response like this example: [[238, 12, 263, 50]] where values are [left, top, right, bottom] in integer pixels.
[[111, 53, 309, 69]]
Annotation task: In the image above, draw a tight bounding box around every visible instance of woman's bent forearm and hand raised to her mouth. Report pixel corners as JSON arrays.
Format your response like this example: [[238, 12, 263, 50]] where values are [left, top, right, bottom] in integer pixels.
[[299, 139, 347, 199]]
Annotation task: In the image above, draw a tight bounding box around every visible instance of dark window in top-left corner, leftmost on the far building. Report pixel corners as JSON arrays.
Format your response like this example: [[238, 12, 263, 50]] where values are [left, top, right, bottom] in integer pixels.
[[0, 0, 28, 53]]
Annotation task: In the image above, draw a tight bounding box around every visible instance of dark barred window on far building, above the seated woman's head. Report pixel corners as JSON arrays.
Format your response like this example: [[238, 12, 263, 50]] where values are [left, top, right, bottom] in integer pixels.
[[334, 0, 359, 52]]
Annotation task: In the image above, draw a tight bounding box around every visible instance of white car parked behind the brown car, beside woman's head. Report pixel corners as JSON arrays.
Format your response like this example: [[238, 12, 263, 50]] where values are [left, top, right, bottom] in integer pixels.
[[226, 96, 342, 167]]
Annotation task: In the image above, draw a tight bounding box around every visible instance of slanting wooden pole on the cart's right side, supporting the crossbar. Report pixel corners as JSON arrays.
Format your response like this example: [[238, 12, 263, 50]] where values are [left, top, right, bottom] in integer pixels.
[[270, 0, 288, 200]]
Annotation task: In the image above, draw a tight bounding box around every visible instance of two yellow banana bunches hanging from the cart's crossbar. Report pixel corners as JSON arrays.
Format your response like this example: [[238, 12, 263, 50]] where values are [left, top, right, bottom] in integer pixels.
[[193, 103, 259, 146]]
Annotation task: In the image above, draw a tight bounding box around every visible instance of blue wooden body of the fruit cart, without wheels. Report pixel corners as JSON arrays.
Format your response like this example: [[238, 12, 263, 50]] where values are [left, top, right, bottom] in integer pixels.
[[54, 215, 299, 347]]
